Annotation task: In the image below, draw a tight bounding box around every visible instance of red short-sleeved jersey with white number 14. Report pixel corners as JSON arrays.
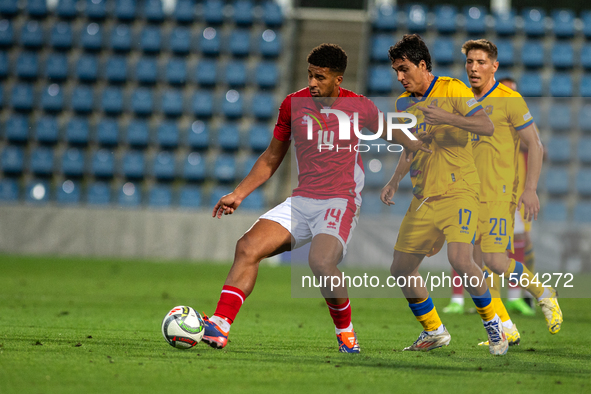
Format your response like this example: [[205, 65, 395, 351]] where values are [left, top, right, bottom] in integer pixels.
[[273, 88, 385, 205]]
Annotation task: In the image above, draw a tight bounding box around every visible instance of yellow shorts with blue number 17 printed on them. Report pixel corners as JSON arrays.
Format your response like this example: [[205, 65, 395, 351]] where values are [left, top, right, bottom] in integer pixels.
[[394, 180, 480, 256]]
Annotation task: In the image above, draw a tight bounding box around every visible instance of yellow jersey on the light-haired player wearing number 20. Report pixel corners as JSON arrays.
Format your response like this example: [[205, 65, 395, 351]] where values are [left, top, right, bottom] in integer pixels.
[[472, 82, 534, 202]]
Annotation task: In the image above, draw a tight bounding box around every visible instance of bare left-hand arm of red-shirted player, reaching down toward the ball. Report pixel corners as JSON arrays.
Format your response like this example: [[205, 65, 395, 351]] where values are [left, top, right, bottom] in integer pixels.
[[212, 137, 291, 219]]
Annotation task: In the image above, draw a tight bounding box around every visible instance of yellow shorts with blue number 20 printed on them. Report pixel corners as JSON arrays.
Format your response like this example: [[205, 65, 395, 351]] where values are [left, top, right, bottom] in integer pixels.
[[476, 201, 515, 253]]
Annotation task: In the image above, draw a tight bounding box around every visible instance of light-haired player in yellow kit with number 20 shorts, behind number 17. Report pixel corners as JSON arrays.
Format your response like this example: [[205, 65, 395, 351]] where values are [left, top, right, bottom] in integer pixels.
[[462, 39, 562, 341]]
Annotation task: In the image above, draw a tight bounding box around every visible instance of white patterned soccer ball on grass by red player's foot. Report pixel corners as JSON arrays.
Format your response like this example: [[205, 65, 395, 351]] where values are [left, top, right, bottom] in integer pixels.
[[162, 305, 205, 349]]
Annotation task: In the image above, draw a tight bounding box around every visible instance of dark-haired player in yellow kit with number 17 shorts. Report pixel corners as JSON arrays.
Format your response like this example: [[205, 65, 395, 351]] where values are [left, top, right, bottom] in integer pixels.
[[380, 34, 508, 355]]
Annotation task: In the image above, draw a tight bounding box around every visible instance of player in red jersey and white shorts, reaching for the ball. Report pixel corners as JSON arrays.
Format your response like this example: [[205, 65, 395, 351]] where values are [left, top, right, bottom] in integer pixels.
[[203, 44, 428, 353]]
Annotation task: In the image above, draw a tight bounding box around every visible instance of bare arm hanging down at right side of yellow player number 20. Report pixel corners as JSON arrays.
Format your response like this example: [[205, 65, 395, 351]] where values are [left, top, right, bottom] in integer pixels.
[[517, 123, 544, 221]]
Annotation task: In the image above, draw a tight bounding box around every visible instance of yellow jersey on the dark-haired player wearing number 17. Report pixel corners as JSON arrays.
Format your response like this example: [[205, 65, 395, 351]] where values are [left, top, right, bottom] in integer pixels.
[[395, 77, 482, 199]]
